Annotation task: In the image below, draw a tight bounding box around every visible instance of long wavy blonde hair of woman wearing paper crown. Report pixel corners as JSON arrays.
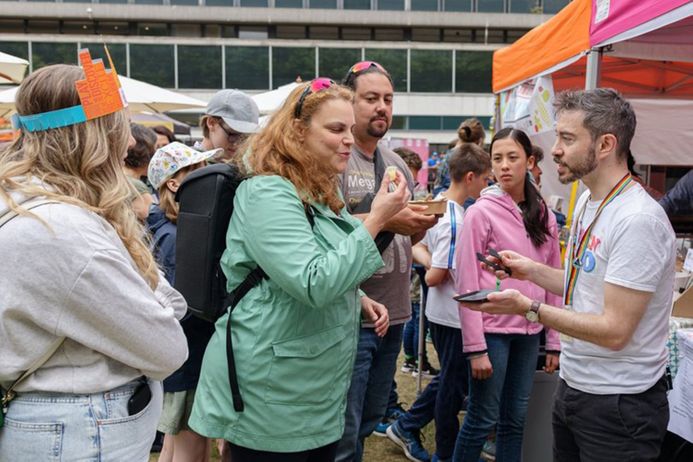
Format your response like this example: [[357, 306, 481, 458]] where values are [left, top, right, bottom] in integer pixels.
[[0, 64, 159, 289]]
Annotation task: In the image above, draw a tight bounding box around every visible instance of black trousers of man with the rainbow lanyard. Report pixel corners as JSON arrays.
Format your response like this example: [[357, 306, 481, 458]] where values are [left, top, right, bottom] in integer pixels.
[[553, 378, 669, 462]]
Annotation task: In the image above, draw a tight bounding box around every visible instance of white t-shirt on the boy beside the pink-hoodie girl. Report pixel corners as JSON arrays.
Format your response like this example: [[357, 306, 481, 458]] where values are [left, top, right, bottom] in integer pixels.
[[422, 199, 464, 329]]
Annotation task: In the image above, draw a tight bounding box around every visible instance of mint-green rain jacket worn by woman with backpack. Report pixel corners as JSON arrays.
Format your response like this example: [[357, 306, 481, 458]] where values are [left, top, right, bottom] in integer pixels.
[[189, 176, 383, 452]]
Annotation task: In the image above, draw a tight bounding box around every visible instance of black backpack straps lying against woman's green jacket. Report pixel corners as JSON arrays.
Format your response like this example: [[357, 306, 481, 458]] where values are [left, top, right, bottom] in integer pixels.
[[225, 202, 315, 412]]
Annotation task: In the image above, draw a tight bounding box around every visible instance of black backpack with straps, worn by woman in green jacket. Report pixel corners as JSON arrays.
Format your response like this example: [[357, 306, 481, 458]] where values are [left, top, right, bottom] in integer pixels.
[[175, 163, 314, 412]]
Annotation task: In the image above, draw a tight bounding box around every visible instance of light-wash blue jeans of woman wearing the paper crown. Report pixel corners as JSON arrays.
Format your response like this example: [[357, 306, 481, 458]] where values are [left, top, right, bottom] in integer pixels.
[[0, 381, 163, 462]]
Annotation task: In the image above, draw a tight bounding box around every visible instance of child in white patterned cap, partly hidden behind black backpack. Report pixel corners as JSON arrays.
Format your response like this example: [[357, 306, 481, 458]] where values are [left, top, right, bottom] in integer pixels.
[[147, 142, 221, 462]]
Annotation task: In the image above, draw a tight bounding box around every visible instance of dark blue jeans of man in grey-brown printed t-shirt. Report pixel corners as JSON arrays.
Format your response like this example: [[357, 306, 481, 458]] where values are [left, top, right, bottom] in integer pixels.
[[336, 324, 403, 462]]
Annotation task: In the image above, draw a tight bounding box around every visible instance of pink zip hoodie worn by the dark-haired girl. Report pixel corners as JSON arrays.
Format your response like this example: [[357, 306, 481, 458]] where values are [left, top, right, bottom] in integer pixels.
[[455, 186, 563, 353]]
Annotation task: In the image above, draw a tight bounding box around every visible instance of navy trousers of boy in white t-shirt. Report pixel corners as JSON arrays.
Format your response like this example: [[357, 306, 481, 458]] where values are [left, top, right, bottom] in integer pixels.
[[397, 322, 468, 459]]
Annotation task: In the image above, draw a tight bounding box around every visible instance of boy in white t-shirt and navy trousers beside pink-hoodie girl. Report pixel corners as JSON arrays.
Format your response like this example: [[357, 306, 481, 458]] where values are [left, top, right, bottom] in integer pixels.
[[387, 143, 491, 461]]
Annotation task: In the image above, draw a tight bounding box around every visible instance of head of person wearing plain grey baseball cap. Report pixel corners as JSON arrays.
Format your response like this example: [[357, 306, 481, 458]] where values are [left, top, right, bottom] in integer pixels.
[[195, 90, 260, 161]]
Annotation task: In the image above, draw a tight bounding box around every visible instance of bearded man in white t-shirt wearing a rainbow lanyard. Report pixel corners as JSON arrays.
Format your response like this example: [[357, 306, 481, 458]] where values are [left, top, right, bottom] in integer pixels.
[[462, 88, 675, 462]]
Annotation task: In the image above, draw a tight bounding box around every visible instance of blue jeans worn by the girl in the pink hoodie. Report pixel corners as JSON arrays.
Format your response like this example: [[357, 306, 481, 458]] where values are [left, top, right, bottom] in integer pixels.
[[453, 334, 539, 462]]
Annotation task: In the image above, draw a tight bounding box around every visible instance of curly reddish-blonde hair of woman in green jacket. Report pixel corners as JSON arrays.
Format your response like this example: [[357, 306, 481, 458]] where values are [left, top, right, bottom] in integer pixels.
[[241, 82, 354, 213]]
